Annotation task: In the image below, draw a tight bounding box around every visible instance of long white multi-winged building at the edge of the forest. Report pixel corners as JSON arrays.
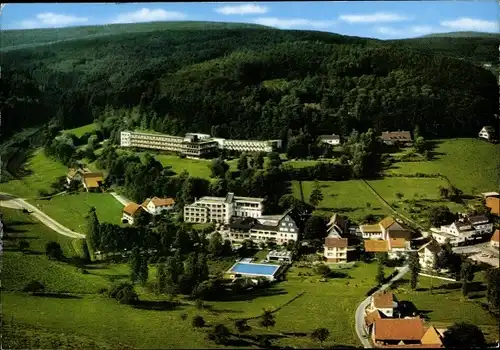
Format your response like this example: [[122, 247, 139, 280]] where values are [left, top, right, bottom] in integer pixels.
[[120, 131, 282, 158]]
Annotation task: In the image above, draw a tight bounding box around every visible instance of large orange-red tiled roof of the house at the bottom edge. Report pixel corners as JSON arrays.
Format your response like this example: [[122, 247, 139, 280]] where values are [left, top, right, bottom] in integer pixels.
[[373, 318, 425, 341]]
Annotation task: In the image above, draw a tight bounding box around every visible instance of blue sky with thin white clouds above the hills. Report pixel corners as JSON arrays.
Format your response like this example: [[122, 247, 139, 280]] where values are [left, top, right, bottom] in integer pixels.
[[1, 0, 500, 39]]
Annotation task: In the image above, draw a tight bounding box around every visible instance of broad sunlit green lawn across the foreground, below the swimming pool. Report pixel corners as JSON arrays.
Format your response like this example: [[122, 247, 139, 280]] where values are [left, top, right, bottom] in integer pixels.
[[3, 264, 389, 348]]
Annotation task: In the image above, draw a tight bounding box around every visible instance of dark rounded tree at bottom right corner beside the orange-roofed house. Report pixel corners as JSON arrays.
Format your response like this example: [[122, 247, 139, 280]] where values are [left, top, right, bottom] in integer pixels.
[[443, 322, 486, 349]]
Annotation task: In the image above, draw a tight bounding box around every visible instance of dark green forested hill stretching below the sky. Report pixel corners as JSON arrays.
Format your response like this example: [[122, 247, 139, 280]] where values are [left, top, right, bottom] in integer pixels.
[[1, 22, 498, 138]]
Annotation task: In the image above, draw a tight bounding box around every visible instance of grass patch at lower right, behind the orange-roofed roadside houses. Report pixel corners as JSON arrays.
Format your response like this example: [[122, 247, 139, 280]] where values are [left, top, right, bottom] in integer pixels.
[[394, 272, 499, 342]]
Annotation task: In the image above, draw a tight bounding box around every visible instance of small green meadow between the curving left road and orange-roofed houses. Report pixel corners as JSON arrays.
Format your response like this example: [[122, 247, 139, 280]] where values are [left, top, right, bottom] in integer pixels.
[[30, 192, 123, 233]]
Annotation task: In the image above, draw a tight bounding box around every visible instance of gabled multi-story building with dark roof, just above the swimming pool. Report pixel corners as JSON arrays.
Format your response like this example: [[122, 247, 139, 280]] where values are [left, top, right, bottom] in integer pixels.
[[225, 210, 299, 244]]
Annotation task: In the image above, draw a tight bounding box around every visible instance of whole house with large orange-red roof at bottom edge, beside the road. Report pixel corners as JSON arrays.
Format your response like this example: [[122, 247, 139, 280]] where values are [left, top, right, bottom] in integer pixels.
[[372, 317, 443, 348]]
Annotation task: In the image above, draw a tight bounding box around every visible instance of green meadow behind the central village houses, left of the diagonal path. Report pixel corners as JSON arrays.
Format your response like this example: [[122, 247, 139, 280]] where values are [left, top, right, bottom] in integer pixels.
[[292, 180, 390, 221]]
